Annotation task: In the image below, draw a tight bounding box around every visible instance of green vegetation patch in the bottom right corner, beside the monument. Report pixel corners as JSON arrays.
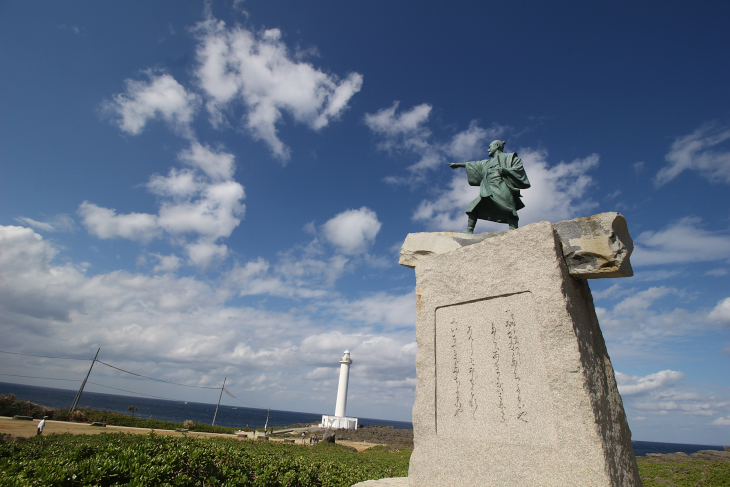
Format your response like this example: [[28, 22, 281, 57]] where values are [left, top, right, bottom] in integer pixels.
[[639, 460, 730, 487]]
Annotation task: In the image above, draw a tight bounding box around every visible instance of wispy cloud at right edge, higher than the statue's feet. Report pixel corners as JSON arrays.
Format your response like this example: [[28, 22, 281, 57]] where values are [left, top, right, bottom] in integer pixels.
[[654, 124, 730, 186]]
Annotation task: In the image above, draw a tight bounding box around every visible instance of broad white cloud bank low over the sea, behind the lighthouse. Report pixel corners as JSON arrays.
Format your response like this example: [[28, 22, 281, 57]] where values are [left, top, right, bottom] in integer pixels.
[[0, 226, 415, 417]]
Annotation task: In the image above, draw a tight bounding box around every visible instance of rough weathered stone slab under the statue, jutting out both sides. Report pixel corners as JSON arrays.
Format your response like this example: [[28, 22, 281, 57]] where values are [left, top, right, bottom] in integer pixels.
[[399, 212, 634, 279]]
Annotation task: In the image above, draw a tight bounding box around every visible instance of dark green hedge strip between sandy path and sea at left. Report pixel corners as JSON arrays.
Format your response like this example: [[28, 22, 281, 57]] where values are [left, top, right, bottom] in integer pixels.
[[0, 394, 239, 434]]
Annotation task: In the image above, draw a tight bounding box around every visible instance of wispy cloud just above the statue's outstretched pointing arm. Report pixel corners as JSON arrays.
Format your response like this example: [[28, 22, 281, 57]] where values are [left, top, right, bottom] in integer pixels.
[[364, 101, 506, 179]]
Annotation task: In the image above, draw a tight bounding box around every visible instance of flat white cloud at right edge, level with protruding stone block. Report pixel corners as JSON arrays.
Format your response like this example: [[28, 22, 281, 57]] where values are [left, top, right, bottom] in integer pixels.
[[631, 217, 730, 266]]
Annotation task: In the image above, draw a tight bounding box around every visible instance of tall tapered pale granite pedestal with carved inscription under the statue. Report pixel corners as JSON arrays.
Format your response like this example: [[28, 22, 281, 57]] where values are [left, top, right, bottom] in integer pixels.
[[396, 218, 641, 487]]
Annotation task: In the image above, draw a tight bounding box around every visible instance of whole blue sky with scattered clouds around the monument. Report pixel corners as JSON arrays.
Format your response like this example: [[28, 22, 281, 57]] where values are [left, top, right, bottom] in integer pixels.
[[0, 1, 730, 444]]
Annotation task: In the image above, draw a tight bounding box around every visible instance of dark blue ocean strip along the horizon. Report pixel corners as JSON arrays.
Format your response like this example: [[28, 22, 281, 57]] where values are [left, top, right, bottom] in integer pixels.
[[0, 382, 722, 456]]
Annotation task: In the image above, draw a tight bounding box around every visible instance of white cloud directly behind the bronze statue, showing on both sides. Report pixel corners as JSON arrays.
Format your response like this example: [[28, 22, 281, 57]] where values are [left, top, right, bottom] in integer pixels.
[[413, 148, 599, 231]]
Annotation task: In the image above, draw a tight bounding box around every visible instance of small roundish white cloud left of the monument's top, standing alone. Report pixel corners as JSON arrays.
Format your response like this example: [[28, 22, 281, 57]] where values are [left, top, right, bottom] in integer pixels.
[[322, 206, 382, 255]]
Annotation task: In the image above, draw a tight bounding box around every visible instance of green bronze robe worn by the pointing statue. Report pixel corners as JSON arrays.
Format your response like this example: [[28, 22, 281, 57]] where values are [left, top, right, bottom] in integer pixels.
[[466, 152, 530, 223]]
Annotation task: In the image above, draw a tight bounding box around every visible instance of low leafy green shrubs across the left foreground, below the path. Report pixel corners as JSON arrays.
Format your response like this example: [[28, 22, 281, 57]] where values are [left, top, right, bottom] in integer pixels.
[[0, 432, 411, 487]]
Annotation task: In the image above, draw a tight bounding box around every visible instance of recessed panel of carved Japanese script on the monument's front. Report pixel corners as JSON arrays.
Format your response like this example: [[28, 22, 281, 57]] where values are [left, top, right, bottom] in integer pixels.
[[435, 292, 557, 446]]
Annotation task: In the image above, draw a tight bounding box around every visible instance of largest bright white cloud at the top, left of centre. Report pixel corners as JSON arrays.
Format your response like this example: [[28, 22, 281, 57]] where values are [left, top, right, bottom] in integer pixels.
[[194, 19, 363, 161]]
